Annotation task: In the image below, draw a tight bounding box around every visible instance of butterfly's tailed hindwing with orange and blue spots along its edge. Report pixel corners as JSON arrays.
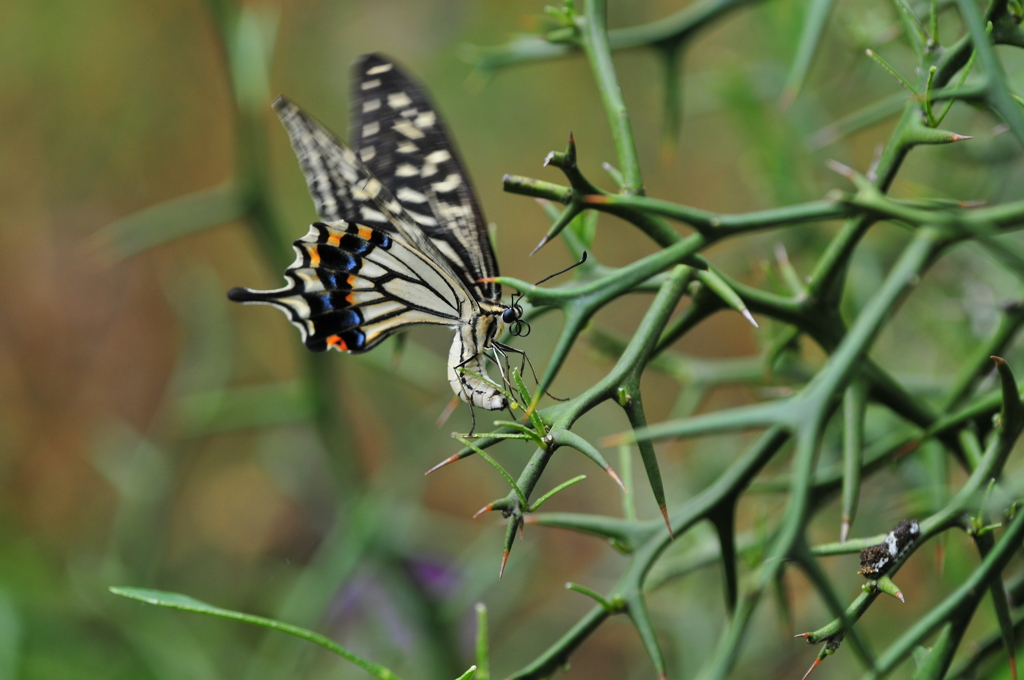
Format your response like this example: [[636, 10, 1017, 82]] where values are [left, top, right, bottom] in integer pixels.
[[227, 221, 472, 352]]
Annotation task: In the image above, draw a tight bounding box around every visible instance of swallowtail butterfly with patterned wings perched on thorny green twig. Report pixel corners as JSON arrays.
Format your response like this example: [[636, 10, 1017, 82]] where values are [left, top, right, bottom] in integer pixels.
[[227, 54, 528, 411]]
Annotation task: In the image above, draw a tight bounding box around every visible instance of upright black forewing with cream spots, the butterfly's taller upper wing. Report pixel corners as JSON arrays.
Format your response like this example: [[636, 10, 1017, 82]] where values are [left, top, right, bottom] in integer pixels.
[[349, 54, 501, 302]]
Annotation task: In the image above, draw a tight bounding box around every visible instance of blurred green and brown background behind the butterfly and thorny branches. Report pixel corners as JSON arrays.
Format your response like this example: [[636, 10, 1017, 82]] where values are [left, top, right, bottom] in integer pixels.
[[6, 0, 1024, 679]]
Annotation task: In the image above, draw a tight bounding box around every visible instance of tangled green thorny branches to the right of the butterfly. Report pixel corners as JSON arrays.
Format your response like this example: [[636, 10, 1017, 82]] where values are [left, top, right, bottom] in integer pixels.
[[454, 0, 1024, 680]]
